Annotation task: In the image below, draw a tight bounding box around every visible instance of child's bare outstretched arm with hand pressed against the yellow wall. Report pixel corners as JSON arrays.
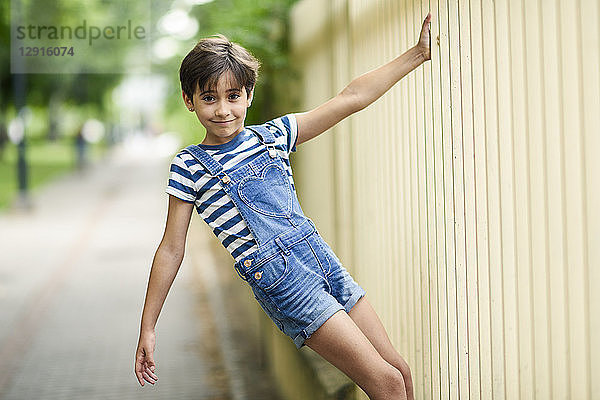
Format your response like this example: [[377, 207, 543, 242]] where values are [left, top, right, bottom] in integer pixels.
[[296, 14, 431, 144]]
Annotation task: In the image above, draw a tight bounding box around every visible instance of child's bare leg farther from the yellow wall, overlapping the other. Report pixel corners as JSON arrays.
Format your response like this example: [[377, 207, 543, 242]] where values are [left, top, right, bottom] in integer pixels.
[[304, 310, 406, 400]]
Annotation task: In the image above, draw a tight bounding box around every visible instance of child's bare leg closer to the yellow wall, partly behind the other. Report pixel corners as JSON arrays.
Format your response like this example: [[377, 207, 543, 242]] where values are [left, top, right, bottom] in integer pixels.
[[348, 296, 414, 400]]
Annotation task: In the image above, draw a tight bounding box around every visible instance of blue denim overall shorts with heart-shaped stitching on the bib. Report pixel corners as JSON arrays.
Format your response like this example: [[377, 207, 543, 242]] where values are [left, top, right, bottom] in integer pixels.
[[185, 125, 365, 349]]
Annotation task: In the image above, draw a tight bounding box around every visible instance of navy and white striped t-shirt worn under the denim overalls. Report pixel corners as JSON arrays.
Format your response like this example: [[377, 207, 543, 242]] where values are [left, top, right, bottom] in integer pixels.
[[166, 114, 298, 262]]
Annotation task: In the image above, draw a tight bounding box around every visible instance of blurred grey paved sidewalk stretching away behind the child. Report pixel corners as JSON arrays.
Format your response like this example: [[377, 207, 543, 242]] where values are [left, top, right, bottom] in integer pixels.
[[0, 135, 282, 400]]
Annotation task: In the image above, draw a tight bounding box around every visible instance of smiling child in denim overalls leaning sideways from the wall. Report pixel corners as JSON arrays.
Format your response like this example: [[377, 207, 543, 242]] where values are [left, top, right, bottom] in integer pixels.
[[135, 14, 431, 399]]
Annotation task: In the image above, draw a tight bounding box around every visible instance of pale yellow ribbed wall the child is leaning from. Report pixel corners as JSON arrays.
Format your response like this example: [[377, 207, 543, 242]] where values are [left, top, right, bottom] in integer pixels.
[[291, 0, 600, 399]]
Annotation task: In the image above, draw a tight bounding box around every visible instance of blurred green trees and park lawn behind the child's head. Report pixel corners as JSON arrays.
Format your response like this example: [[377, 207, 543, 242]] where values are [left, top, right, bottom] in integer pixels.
[[0, 0, 294, 208]]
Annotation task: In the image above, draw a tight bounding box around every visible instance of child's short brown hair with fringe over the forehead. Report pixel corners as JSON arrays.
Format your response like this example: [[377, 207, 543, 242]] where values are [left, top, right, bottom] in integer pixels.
[[179, 34, 260, 102]]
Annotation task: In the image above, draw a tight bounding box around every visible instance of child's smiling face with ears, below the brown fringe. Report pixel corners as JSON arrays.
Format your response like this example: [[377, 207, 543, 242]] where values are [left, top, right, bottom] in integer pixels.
[[183, 72, 253, 144]]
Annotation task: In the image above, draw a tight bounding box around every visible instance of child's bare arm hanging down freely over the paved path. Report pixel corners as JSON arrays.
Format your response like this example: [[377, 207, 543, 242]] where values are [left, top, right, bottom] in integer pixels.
[[135, 195, 194, 386]]
